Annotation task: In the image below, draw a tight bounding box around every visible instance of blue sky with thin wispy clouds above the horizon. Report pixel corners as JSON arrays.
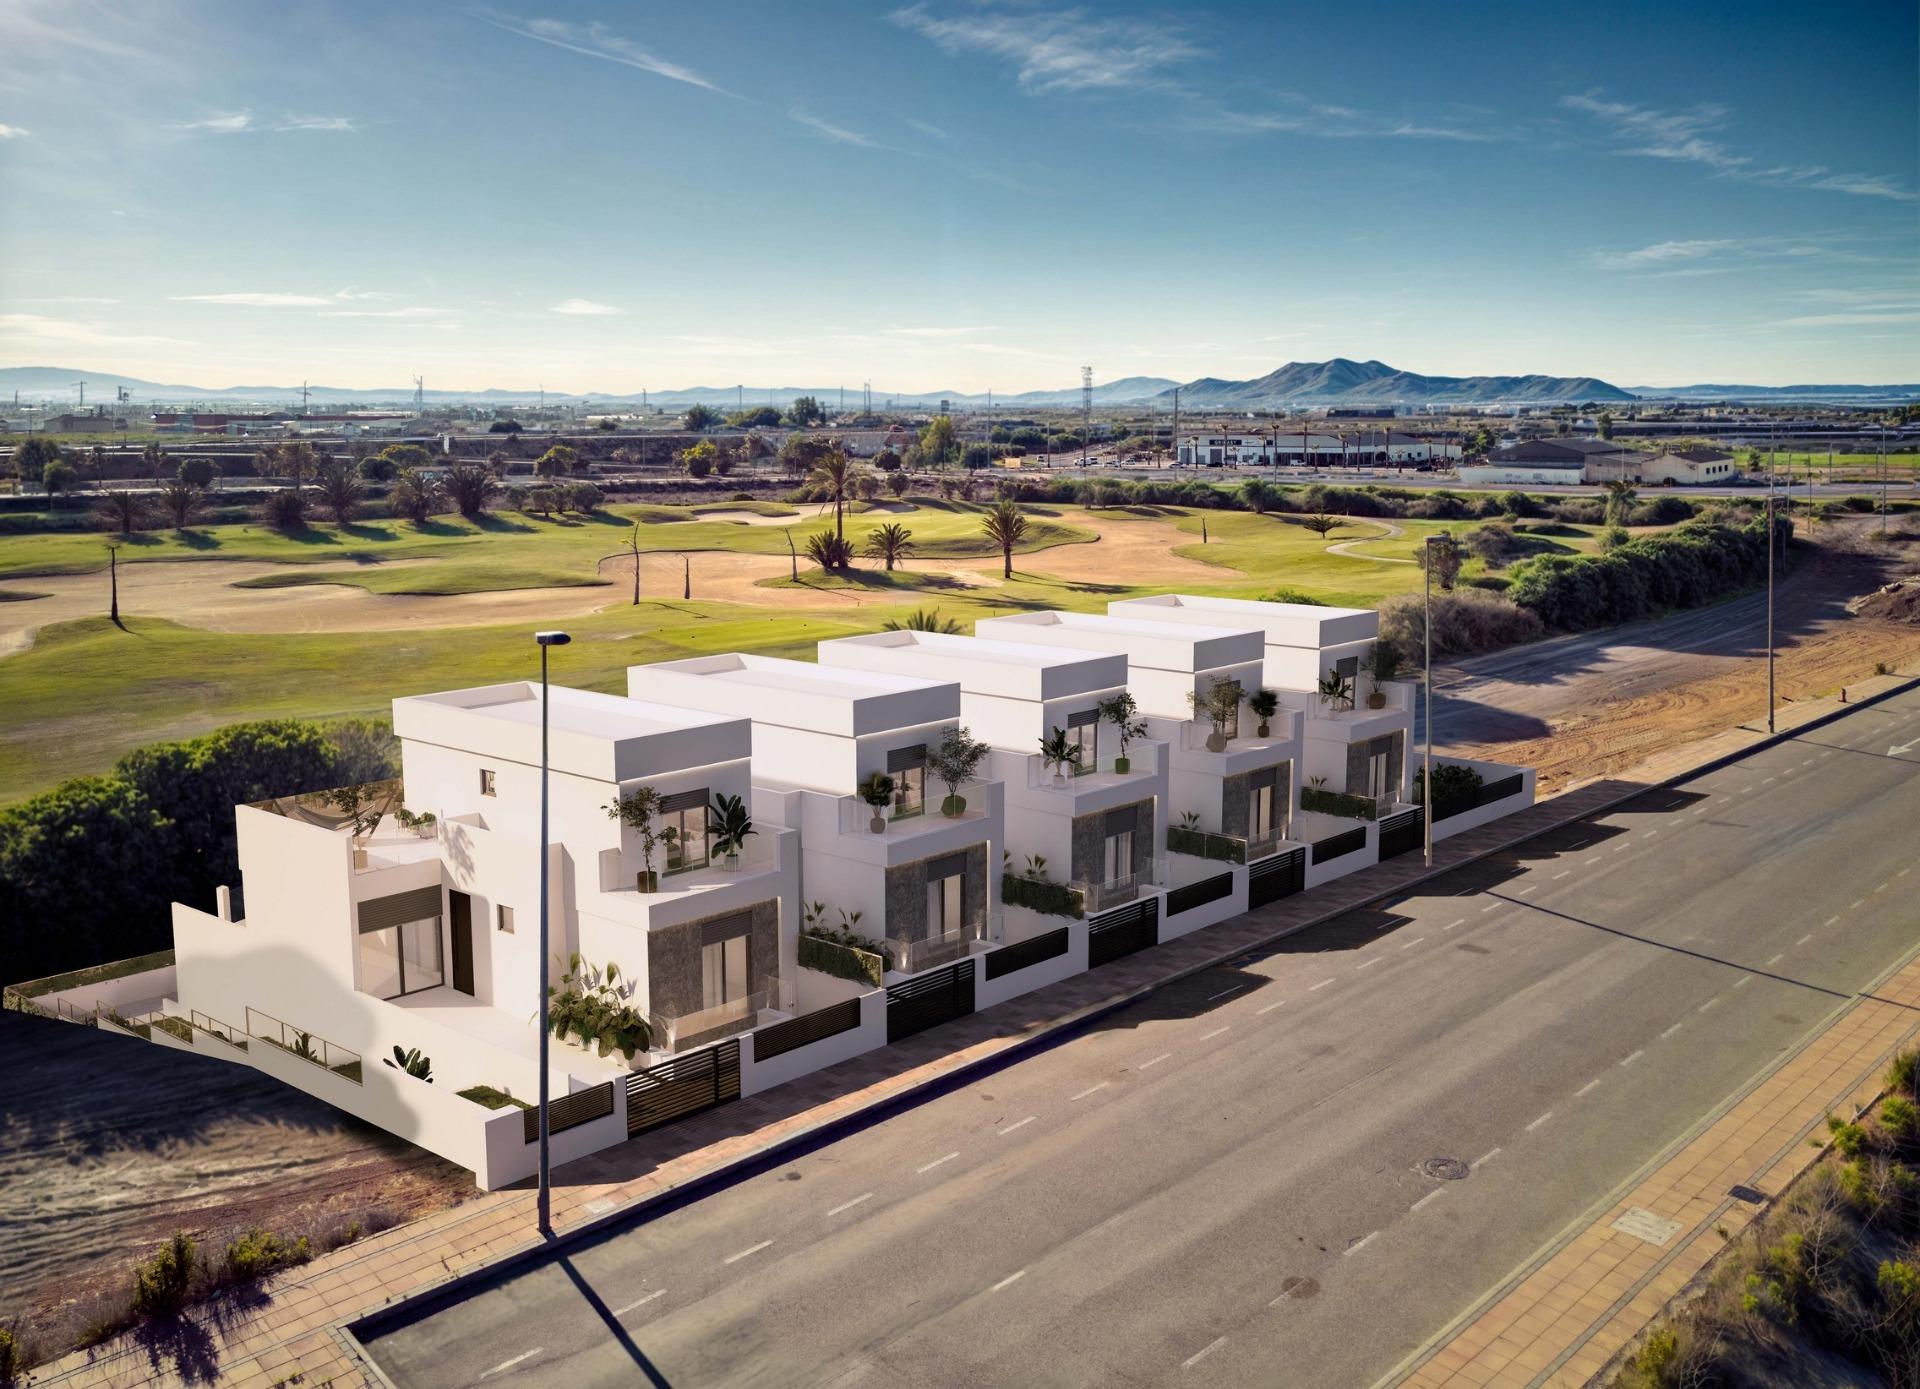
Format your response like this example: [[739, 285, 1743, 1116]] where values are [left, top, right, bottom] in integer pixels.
[[0, 0, 1920, 392]]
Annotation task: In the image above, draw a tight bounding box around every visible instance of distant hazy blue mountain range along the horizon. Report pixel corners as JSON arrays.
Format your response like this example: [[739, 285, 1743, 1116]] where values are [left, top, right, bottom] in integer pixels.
[[0, 357, 1920, 411]]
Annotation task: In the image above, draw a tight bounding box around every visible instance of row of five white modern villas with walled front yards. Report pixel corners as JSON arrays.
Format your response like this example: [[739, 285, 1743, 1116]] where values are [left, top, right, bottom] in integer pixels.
[[15, 594, 1534, 1189]]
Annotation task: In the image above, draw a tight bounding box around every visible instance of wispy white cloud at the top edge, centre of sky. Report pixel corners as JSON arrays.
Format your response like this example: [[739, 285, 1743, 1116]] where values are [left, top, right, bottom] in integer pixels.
[[891, 4, 1202, 92]]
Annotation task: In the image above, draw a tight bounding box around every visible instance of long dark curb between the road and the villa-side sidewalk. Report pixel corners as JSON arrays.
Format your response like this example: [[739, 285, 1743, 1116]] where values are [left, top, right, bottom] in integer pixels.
[[332, 676, 1920, 1387]]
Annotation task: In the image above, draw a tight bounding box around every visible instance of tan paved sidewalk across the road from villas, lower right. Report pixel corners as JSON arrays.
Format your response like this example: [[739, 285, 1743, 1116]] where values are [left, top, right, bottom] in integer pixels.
[[1390, 961, 1920, 1389]]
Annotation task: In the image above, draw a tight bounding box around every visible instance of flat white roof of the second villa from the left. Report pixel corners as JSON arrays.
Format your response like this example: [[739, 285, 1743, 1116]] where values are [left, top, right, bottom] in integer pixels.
[[626, 651, 960, 738]]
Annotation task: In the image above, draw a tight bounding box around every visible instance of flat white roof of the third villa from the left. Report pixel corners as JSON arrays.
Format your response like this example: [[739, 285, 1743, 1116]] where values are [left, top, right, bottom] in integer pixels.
[[818, 630, 1127, 699]]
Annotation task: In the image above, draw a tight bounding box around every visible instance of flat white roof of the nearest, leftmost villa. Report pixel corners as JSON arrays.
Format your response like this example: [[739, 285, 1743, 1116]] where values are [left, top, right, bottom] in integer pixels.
[[394, 680, 753, 780]]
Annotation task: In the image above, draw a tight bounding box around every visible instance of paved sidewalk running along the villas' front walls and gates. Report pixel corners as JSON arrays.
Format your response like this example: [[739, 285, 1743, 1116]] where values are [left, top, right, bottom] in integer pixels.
[[33, 678, 1920, 1389]]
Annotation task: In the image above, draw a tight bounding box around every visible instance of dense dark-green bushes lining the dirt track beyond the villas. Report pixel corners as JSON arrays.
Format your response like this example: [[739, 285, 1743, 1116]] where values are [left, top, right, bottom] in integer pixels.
[[1507, 517, 1791, 632]]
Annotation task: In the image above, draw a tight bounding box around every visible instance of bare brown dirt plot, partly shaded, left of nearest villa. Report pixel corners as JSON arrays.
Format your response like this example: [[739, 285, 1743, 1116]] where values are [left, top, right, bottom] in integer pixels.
[[0, 1012, 474, 1360]]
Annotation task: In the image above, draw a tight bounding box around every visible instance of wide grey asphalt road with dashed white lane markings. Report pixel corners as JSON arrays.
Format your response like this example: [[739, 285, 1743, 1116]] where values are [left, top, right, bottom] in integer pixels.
[[360, 694, 1920, 1389]]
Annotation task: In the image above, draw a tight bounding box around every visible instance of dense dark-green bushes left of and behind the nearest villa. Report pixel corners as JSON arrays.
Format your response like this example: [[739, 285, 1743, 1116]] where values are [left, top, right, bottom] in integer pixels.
[[0, 719, 394, 978]]
